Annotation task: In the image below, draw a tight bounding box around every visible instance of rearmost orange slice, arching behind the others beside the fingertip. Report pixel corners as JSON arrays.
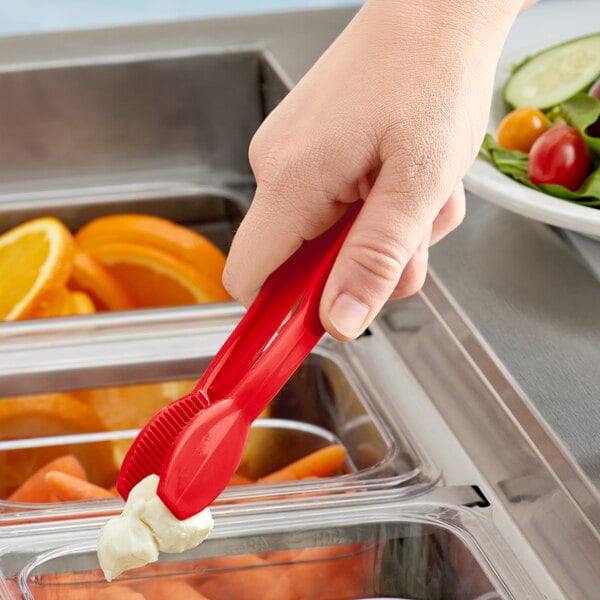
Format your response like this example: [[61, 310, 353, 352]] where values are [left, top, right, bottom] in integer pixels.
[[75, 214, 230, 285]]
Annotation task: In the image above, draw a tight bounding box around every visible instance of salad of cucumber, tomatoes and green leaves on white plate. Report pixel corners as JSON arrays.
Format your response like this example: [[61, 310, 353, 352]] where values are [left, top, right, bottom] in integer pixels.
[[480, 33, 600, 208]]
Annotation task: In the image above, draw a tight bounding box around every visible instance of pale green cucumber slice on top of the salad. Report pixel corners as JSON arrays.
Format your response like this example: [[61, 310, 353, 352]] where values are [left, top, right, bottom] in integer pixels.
[[503, 33, 600, 110]]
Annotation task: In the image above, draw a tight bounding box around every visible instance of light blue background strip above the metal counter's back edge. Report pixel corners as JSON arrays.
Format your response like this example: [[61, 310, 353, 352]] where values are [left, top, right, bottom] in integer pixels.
[[0, 0, 361, 35]]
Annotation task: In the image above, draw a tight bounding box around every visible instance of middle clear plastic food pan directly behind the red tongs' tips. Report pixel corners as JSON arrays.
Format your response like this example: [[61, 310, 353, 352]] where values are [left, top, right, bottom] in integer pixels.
[[0, 323, 440, 526]]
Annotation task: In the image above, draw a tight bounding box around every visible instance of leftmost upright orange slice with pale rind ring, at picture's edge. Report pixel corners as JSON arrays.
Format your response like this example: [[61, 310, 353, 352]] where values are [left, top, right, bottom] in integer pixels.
[[0, 217, 75, 321]]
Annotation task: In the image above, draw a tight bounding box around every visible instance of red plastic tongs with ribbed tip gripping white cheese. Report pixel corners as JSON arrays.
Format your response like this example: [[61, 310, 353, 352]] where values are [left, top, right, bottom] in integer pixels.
[[117, 201, 363, 519]]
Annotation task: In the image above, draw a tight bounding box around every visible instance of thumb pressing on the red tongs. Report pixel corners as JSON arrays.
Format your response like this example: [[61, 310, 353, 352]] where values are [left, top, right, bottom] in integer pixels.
[[319, 165, 437, 340]]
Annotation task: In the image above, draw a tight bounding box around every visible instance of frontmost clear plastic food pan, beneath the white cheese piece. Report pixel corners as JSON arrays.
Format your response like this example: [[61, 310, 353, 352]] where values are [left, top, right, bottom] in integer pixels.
[[0, 502, 544, 600]]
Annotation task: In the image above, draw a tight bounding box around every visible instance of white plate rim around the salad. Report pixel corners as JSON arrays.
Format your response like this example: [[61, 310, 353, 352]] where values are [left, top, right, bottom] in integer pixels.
[[464, 25, 600, 238]]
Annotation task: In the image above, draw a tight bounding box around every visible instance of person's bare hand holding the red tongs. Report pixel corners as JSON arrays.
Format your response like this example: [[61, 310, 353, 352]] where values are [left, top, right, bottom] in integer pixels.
[[224, 0, 536, 340]]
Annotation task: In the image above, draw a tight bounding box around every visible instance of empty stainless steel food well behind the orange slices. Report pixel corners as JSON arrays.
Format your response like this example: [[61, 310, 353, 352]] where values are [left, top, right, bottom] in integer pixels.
[[0, 47, 287, 231]]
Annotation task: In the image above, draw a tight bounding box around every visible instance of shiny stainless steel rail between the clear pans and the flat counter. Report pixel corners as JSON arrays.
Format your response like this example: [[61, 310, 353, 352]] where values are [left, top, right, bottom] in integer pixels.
[[374, 274, 600, 599]]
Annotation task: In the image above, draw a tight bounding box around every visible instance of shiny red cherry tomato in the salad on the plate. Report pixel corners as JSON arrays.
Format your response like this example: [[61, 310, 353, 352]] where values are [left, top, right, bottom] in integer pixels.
[[527, 125, 590, 190]]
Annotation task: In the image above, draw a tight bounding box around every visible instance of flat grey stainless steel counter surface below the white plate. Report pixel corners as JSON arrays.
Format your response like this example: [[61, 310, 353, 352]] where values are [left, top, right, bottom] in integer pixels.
[[431, 195, 600, 487]]
